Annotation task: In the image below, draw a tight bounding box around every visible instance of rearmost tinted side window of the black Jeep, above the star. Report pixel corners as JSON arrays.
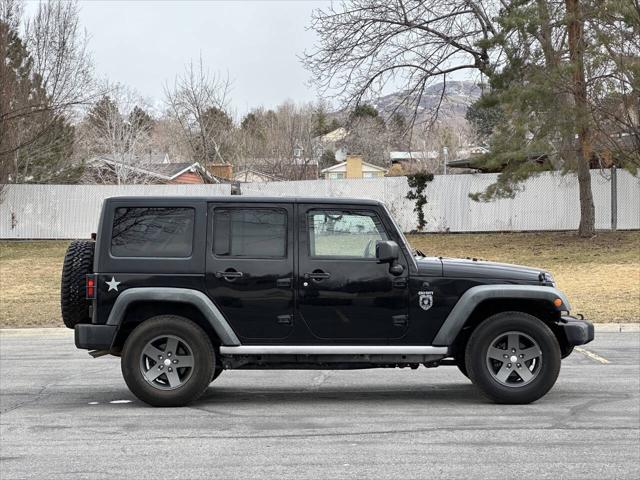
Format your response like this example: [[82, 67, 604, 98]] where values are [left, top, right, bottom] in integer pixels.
[[111, 207, 195, 258]]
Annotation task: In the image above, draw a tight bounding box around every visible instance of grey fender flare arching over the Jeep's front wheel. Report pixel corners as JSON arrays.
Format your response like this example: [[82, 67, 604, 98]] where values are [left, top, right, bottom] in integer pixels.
[[433, 285, 571, 346]]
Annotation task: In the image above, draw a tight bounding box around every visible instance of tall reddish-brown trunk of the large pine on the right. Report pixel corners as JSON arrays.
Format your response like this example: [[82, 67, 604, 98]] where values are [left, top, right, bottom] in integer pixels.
[[565, 0, 595, 237]]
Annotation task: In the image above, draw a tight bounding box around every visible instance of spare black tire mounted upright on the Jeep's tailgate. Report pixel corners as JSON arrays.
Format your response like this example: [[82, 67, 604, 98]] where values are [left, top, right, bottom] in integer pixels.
[[60, 240, 95, 328]]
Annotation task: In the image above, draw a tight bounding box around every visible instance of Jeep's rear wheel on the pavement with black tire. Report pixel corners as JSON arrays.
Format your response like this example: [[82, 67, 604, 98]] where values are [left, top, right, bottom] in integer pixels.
[[120, 315, 215, 407]]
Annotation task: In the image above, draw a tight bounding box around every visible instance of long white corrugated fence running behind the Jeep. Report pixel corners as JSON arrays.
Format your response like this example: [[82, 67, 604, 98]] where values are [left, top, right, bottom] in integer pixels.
[[0, 170, 640, 239]]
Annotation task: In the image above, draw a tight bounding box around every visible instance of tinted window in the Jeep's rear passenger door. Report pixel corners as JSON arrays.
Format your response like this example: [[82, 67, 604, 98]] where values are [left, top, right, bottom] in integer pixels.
[[213, 208, 287, 258]]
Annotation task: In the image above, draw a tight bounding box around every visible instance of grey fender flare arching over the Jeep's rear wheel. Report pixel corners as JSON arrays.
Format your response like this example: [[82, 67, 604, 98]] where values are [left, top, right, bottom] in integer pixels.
[[107, 287, 240, 346]]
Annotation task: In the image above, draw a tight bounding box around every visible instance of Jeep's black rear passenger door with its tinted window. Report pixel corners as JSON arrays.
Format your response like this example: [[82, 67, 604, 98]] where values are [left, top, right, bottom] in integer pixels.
[[206, 203, 294, 343]]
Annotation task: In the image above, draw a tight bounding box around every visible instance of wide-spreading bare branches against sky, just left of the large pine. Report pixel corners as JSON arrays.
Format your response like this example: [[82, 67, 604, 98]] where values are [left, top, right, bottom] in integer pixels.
[[303, 0, 499, 129]]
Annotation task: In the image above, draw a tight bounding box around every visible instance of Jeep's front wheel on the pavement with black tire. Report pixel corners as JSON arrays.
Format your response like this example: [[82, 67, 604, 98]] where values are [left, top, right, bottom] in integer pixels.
[[465, 312, 561, 404]]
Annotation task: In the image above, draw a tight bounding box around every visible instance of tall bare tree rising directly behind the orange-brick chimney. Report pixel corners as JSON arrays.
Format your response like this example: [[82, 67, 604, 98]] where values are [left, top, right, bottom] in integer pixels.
[[164, 59, 232, 166]]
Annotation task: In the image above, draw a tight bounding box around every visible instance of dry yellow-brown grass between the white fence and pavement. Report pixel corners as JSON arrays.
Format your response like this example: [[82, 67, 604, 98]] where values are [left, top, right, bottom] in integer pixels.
[[0, 232, 640, 327]]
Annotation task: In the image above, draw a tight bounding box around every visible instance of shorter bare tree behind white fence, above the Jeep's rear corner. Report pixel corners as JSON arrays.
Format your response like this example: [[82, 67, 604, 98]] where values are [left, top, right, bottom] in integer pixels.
[[81, 85, 152, 185]]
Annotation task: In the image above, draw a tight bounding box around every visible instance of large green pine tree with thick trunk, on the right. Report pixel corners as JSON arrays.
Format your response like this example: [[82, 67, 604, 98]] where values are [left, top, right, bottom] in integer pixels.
[[467, 0, 640, 237]]
